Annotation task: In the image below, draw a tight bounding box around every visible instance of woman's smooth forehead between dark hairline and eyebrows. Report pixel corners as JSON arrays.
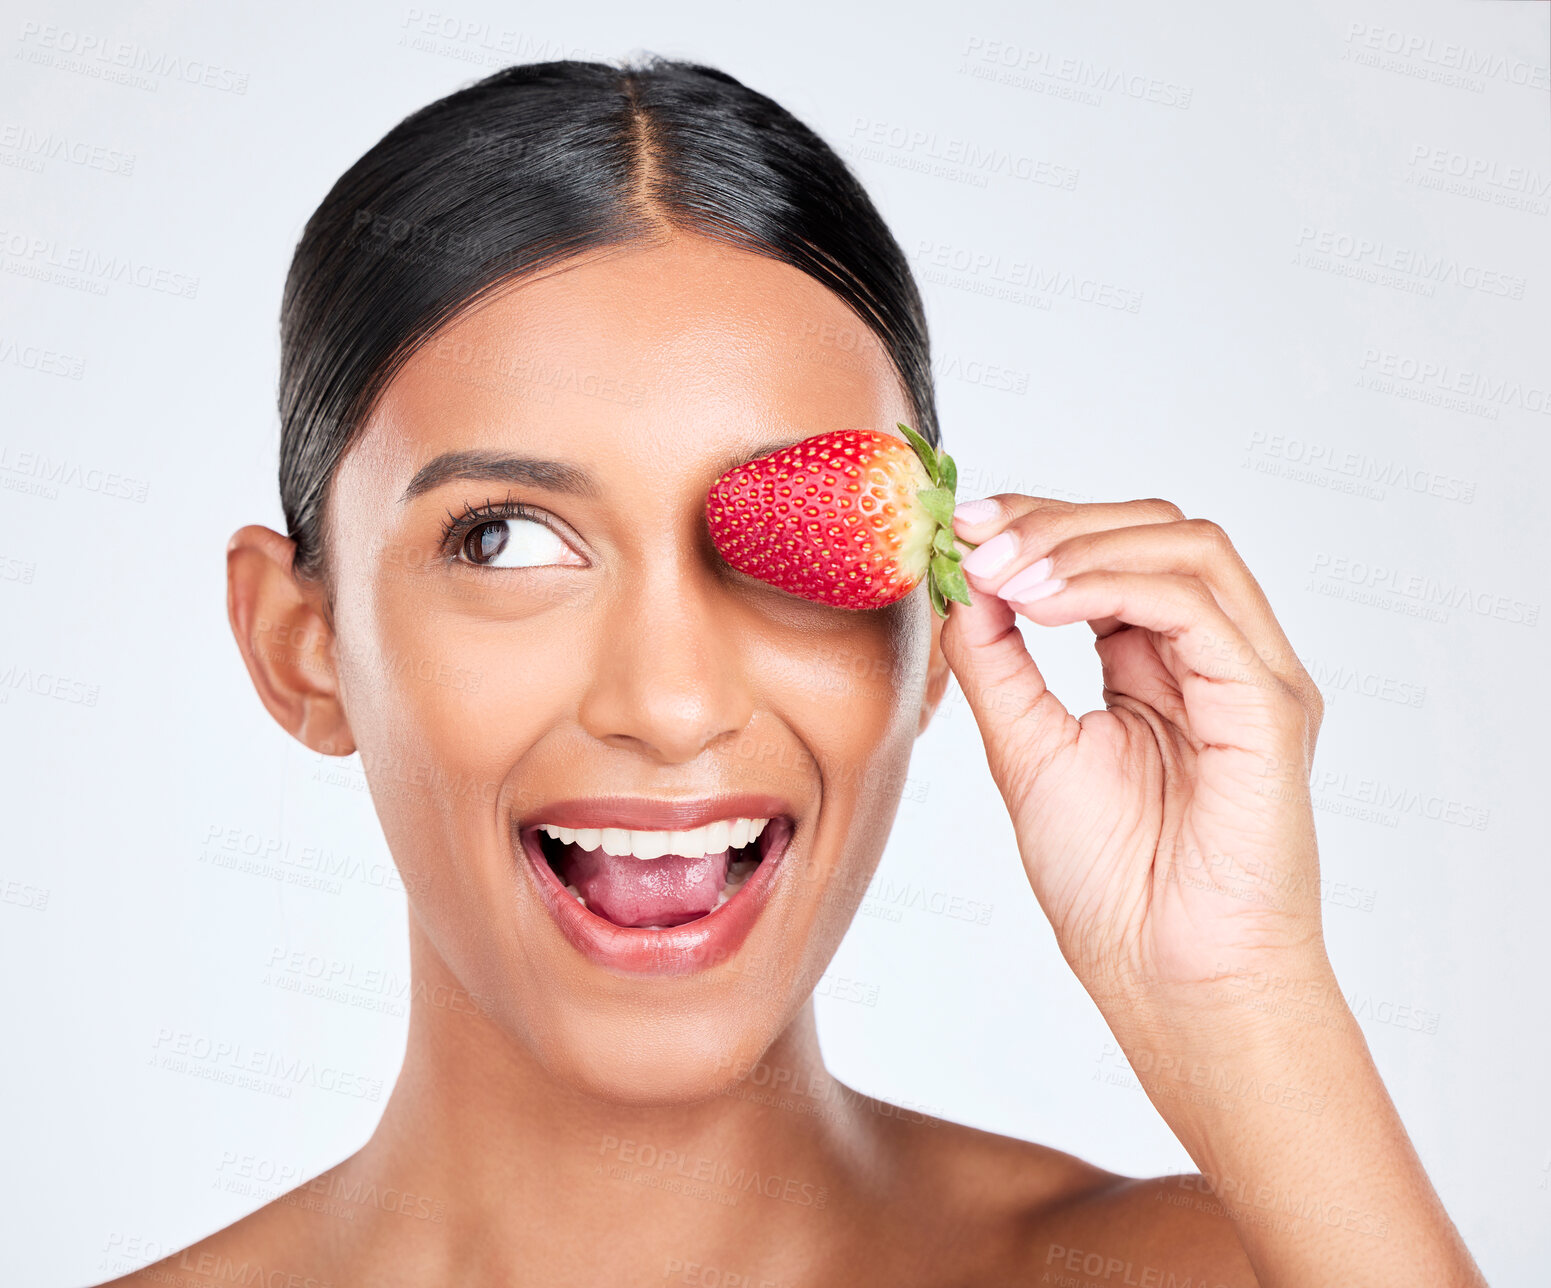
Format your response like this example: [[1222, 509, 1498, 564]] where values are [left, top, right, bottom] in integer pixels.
[[341, 236, 909, 486]]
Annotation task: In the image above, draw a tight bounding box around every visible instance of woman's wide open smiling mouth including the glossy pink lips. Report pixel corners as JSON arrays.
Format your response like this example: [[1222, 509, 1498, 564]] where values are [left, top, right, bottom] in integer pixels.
[[520, 796, 796, 973]]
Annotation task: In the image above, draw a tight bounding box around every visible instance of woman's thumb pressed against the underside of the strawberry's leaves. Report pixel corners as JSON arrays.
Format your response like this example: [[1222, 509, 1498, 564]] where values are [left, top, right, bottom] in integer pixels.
[[943, 593, 1078, 807]]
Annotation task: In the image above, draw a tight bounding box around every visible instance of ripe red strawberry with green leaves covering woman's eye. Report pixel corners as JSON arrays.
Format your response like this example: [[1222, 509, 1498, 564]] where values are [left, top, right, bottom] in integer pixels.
[[706, 425, 969, 618]]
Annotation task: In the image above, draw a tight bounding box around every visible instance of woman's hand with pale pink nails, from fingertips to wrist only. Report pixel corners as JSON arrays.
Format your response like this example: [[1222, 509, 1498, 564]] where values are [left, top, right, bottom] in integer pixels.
[[943, 495, 1328, 1007]]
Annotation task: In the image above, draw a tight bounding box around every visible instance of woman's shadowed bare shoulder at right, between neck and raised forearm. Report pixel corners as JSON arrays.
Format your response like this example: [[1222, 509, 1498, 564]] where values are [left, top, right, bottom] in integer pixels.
[[849, 1092, 1256, 1288]]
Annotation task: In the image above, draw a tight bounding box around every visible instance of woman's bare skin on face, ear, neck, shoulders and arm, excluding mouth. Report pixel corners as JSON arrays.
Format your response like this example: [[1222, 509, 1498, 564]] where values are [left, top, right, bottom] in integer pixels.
[[103, 230, 1481, 1288]]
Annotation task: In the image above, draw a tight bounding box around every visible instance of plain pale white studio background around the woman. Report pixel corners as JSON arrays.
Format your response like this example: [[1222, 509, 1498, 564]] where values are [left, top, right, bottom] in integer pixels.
[[0, 0, 1551, 1285]]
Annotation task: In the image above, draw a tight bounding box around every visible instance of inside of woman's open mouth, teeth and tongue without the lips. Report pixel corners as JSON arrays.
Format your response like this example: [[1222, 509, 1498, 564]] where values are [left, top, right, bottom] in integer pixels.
[[532, 816, 793, 930]]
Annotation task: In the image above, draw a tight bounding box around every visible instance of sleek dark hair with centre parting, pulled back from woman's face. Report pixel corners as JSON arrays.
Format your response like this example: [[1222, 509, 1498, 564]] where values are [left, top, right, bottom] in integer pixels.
[[279, 59, 937, 576]]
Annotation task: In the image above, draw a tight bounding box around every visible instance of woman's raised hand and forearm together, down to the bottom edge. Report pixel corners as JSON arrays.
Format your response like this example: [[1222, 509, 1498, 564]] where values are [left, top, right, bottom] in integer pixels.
[[943, 495, 1484, 1285]]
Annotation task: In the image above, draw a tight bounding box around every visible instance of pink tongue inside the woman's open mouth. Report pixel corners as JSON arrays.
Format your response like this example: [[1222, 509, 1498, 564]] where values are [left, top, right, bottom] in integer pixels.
[[560, 846, 729, 926]]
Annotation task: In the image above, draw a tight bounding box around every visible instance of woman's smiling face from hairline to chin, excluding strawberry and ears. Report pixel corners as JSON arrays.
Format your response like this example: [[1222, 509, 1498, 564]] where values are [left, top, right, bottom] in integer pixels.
[[313, 236, 946, 1103]]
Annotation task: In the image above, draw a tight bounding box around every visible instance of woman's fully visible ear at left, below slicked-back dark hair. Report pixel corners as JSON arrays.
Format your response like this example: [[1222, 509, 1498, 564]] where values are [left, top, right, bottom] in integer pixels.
[[226, 525, 355, 756]]
